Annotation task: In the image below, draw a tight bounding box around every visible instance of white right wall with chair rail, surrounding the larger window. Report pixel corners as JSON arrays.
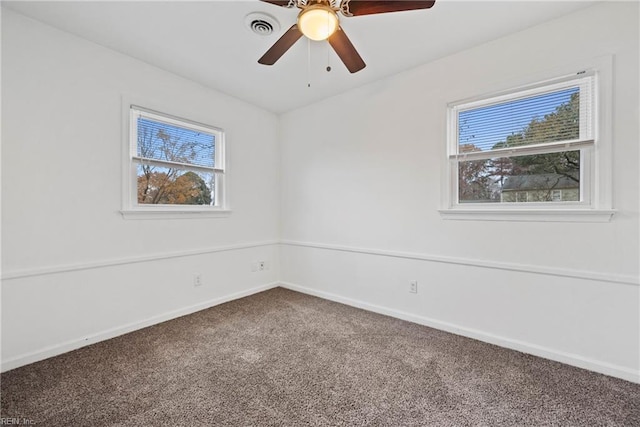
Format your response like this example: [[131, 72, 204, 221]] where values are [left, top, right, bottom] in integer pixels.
[[280, 2, 640, 381]]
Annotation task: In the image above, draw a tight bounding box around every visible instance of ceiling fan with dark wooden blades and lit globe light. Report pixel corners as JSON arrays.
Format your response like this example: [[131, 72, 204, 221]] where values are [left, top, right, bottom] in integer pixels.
[[258, 0, 435, 73]]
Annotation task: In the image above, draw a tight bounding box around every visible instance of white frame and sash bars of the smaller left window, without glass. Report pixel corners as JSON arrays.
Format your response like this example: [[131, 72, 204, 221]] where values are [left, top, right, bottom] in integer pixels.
[[120, 101, 230, 219]]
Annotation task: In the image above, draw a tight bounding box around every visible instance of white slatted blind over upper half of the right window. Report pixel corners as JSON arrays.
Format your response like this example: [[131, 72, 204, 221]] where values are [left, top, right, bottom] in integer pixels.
[[450, 73, 594, 159]]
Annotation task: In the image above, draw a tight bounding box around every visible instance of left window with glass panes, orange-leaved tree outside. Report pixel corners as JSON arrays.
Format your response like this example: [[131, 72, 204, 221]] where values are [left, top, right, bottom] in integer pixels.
[[125, 105, 224, 219]]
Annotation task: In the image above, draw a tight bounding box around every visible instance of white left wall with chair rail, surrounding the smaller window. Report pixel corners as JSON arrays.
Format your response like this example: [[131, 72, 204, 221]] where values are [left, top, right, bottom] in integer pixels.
[[2, 9, 279, 369]]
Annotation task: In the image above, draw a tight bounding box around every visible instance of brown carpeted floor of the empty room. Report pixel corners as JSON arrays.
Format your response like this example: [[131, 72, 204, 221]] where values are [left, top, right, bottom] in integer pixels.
[[1, 288, 640, 427]]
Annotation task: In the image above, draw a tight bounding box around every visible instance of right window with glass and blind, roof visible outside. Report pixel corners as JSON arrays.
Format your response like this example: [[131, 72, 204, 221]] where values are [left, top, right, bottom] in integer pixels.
[[441, 65, 611, 224]]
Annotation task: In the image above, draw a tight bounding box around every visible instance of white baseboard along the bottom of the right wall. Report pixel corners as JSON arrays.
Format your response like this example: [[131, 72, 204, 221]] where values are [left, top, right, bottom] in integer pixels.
[[280, 282, 640, 383]]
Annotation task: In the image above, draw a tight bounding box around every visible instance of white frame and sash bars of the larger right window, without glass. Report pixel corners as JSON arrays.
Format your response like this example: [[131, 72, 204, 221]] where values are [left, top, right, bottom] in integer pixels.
[[439, 56, 615, 222]]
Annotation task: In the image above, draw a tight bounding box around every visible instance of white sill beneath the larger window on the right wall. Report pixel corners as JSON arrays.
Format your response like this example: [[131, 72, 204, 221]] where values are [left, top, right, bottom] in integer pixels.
[[438, 209, 616, 222]]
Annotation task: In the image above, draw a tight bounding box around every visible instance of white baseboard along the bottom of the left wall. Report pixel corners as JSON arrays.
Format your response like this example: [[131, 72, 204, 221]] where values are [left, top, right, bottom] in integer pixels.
[[1, 282, 279, 372]]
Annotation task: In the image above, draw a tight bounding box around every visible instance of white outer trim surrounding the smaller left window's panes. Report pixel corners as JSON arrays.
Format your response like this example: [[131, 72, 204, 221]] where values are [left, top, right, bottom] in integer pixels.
[[119, 95, 231, 220]]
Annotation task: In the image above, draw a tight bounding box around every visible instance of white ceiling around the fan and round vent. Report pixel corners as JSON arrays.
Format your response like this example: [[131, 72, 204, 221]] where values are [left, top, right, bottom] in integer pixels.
[[2, 0, 594, 113]]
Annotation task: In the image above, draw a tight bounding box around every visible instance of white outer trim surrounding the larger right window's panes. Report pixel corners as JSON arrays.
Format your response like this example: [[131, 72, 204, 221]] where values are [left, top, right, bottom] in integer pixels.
[[438, 55, 616, 222]]
